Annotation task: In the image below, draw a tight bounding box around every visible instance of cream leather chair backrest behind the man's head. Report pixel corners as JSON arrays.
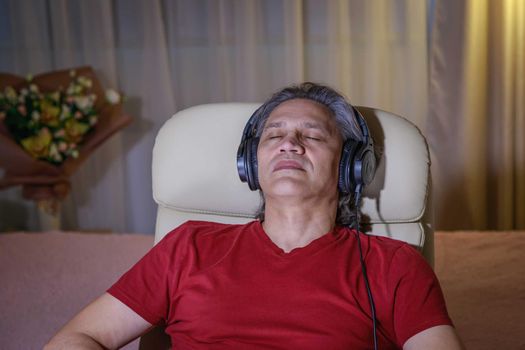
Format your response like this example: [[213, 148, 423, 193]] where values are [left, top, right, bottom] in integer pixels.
[[149, 103, 433, 263]]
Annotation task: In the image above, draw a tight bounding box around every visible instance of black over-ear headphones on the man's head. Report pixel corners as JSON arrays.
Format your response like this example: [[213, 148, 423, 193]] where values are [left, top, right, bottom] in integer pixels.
[[237, 106, 376, 194]]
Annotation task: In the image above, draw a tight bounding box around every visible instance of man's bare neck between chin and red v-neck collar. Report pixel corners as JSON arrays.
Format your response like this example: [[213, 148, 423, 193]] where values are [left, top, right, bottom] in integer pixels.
[[263, 198, 337, 252]]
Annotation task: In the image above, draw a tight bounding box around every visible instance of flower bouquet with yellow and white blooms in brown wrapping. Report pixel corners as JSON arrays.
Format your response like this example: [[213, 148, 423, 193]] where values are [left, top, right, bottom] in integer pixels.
[[0, 67, 131, 226]]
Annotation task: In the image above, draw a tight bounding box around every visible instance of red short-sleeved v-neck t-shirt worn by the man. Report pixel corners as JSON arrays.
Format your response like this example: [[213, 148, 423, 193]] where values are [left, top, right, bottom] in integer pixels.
[[108, 221, 452, 350]]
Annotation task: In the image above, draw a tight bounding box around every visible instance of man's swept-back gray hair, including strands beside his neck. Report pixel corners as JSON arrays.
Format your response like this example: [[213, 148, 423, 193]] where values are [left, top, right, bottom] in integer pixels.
[[254, 82, 364, 225]]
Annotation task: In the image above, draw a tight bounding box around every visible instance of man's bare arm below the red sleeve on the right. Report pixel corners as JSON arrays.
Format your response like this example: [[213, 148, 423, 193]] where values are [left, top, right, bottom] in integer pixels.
[[403, 325, 463, 350]]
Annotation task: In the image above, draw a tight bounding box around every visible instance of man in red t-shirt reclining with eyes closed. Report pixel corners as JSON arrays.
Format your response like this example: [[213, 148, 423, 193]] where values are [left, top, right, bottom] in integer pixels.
[[48, 83, 461, 350]]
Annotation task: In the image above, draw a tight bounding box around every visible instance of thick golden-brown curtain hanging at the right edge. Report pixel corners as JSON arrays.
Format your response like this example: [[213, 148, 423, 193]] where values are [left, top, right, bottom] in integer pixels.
[[427, 0, 525, 230]]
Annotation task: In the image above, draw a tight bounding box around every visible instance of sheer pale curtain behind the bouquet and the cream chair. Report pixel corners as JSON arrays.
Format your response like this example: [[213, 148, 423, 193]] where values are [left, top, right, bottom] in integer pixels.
[[0, 0, 428, 232]]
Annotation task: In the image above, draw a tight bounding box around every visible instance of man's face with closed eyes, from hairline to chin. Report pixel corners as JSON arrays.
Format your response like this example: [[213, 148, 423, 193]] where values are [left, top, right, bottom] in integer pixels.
[[257, 99, 342, 199]]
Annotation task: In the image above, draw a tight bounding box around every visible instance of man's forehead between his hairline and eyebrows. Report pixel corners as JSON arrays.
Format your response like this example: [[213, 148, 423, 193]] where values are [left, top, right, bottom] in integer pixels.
[[264, 98, 337, 131]]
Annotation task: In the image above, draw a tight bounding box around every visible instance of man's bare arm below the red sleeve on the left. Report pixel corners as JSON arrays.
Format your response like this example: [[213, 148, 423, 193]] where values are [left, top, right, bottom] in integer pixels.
[[48, 293, 153, 349]]
